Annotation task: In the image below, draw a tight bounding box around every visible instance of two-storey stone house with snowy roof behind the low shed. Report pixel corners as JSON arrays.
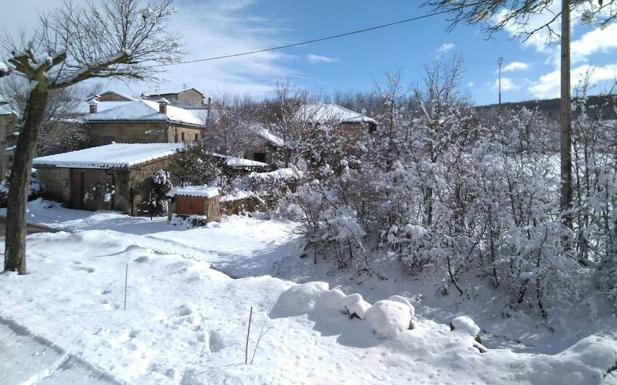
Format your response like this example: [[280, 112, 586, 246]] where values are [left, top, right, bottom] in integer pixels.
[[83, 99, 205, 146]]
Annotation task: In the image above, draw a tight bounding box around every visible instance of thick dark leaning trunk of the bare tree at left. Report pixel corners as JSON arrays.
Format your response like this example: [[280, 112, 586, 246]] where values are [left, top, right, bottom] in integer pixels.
[[4, 85, 48, 275]]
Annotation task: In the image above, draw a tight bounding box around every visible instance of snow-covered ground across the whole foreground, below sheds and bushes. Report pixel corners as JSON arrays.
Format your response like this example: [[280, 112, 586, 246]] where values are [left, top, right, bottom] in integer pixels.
[[0, 201, 617, 385]]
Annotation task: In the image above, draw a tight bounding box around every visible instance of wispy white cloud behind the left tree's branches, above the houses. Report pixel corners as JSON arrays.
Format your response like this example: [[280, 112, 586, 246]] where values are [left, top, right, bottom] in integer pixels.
[[0, 0, 297, 96]]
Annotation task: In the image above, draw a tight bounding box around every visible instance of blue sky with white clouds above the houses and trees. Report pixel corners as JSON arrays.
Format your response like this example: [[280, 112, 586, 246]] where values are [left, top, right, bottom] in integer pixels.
[[0, 0, 617, 104]]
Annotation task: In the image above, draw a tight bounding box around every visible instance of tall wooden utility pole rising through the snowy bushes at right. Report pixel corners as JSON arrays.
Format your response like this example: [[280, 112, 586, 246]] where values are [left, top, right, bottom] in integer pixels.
[[559, 0, 572, 240]]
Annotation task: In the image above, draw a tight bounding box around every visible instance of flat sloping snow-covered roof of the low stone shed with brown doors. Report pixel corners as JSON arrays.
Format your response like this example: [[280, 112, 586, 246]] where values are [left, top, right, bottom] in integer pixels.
[[32, 143, 184, 169]]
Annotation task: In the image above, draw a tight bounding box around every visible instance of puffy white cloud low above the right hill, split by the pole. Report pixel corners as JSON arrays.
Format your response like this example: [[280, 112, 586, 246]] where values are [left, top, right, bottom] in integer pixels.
[[528, 63, 617, 99]]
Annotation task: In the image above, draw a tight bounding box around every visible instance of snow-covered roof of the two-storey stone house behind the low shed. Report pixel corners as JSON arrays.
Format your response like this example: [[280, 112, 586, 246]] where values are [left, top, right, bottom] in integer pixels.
[[85, 99, 205, 126]]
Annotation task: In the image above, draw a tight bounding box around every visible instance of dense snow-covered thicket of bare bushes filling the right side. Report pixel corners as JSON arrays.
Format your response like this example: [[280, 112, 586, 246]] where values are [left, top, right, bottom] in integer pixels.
[[279, 68, 617, 316]]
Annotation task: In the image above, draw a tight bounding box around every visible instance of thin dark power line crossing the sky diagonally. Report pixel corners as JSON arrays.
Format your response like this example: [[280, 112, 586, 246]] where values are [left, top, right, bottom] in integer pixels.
[[153, 11, 449, 67]]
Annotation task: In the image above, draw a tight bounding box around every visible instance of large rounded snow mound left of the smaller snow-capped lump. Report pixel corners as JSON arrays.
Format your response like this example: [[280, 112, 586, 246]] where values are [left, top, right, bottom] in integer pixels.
[[366, 299, 413, 338]]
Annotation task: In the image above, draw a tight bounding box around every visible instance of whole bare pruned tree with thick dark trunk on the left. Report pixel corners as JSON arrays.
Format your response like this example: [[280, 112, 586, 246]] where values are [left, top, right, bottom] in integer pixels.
[[1, 0, 180, 274]]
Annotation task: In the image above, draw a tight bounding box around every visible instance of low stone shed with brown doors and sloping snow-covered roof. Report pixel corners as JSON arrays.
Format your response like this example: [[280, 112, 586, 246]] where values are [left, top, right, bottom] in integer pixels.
[[33, 143, 184, 215]]
